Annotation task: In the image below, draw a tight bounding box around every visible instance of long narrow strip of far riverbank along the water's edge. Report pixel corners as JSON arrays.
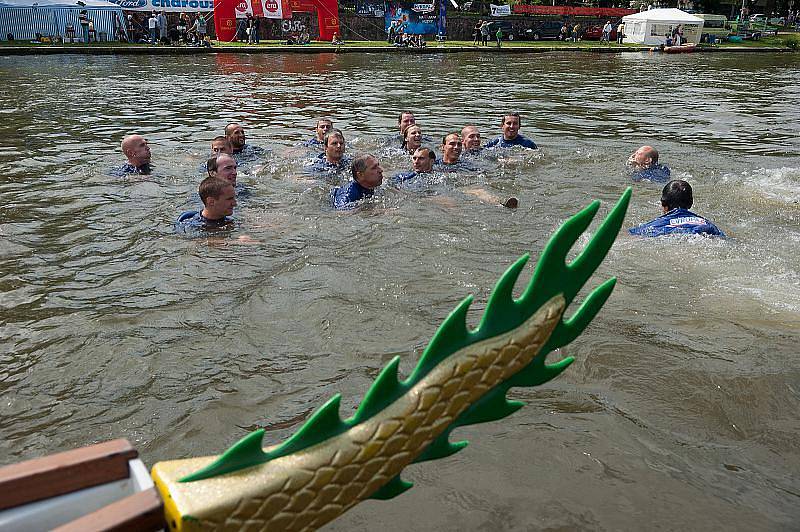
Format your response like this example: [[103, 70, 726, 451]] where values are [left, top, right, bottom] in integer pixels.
[[0, 37, 797, 55]]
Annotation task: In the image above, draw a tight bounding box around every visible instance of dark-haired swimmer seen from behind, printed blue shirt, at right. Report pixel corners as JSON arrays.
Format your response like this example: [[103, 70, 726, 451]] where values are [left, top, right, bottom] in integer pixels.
[[628, 179, 725, 237]]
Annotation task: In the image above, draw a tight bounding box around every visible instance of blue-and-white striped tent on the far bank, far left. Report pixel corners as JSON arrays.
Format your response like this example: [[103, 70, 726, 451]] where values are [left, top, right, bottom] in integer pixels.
[[0, 0, 125, 42]]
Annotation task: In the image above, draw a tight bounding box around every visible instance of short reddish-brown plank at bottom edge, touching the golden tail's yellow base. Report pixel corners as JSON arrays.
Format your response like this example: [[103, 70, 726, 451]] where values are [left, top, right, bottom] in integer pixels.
[[54, 488, 167, 532]]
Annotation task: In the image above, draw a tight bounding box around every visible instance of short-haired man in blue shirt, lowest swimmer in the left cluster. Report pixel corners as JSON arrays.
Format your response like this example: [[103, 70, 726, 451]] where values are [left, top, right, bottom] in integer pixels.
[[175, 177, 236, 233]]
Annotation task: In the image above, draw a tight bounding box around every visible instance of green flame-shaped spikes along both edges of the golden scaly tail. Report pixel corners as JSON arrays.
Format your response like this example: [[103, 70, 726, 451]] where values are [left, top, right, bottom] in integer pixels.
[[181, 188, 631, 490]]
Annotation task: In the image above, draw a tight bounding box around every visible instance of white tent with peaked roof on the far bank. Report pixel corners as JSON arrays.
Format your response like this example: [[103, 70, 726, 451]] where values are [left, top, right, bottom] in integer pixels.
[[622, 8, 703, 45]]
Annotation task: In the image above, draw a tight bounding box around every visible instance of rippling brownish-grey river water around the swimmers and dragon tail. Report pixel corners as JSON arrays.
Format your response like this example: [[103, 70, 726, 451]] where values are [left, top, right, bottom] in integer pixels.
[[0, 53, 800, 531]]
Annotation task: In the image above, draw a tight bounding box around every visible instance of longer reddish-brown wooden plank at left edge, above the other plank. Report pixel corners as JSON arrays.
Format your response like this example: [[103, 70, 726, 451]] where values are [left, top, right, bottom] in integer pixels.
[[0, 439, 139, 510]]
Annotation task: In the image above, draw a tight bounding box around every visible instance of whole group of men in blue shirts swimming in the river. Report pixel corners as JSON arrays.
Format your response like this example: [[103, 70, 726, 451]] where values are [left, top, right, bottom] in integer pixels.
[[117, 111, 724, 236]]
